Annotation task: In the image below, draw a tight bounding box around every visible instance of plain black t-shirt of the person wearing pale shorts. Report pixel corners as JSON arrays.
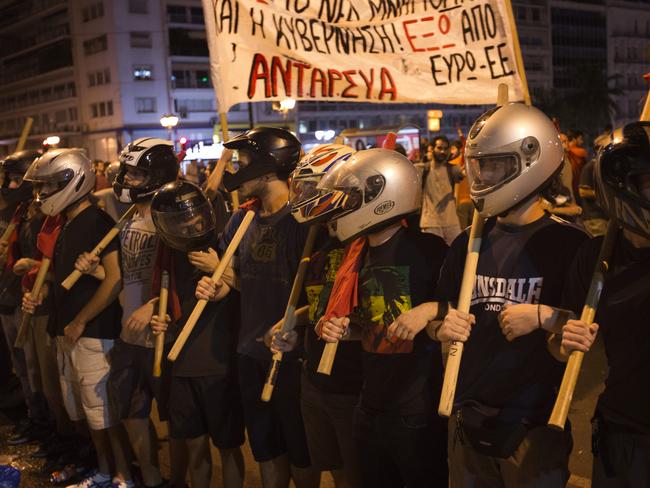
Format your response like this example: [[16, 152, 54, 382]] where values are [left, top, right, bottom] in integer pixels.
[[50, 205, 122, 339]]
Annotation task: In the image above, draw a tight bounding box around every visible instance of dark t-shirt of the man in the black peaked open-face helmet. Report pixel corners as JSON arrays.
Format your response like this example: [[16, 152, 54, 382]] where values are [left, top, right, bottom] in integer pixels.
[[220, 205, 308, 359]]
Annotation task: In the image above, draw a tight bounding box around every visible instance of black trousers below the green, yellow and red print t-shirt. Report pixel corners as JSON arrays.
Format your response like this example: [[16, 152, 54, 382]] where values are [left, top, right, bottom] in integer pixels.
[[354, 407, 448, 488]]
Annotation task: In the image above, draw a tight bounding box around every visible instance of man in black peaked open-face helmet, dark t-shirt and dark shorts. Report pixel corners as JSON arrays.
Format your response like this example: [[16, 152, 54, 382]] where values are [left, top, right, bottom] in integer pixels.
[[192, 127, 319, 488]]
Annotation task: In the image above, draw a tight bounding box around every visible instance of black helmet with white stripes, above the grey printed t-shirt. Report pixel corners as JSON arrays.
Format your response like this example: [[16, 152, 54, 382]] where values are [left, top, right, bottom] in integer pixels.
[[113, 137, 180, 203]]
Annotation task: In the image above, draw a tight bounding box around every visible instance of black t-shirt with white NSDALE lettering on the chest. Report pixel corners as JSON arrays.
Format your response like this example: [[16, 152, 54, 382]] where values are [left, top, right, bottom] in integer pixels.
[[438, 214, 587, 423]]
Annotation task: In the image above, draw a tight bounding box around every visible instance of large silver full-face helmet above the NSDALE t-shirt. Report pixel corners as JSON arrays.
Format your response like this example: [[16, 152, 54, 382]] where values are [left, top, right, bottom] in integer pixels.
[[465, 103, 564, 217]]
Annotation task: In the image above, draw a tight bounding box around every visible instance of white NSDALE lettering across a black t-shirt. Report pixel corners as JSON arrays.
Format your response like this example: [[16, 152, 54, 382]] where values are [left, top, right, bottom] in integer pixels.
[[471, 275, 544, 312]]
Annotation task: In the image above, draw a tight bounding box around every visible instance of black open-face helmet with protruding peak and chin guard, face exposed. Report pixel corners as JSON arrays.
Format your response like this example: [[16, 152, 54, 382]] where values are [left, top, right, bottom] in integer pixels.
[[223, 127, 301, 191]]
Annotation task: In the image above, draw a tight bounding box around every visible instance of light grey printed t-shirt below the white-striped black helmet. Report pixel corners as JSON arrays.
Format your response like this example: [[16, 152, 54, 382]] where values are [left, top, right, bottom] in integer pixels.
[[120, 214, 158, 347]]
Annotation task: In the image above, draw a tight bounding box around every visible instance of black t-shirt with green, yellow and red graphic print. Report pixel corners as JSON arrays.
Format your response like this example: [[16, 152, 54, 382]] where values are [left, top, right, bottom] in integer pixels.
[[354, 229, 447, 415]]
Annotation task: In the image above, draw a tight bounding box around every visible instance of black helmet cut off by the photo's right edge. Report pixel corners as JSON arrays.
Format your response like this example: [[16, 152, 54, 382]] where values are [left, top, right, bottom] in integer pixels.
[[595, 122, 650, 239]]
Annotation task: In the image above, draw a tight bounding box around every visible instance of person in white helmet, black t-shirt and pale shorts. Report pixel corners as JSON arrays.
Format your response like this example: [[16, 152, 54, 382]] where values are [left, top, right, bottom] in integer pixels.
[[23, 149, 133, 488]]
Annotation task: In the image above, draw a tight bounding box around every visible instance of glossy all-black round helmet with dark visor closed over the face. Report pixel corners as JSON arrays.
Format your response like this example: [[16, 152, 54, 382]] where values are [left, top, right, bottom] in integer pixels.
[[151, 180, 216, 252]]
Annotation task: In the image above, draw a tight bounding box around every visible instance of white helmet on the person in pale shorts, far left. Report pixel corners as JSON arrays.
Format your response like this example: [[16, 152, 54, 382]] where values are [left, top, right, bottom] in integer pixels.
[[24, 149, 95, 216]]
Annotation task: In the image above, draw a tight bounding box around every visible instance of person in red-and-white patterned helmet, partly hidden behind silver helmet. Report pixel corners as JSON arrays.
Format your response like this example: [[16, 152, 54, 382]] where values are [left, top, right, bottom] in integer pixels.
[[265, 144, 362, 488]]
